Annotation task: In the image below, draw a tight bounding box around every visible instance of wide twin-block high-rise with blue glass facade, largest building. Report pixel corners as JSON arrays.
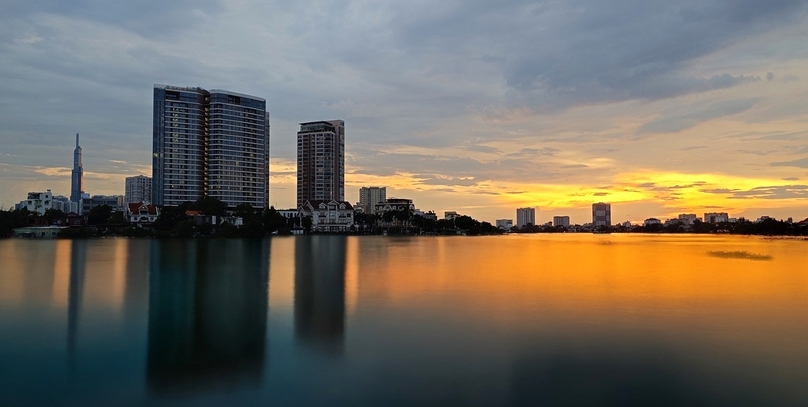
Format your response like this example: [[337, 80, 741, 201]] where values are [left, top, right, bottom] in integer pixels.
[[152, 85, 269, 208]]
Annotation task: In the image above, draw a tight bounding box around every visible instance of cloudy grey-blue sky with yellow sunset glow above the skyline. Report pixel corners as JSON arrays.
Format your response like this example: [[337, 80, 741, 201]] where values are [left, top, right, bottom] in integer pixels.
[[0, 0, 808, 224]]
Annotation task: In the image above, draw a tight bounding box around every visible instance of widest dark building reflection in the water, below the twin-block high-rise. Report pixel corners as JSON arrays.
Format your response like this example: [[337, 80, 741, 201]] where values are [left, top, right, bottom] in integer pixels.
[[146, 240, 269, 393]]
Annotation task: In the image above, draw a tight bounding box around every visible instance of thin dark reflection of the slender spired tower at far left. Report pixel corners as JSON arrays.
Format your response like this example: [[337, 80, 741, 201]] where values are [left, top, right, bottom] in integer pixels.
[[67, 239, 87, 368]]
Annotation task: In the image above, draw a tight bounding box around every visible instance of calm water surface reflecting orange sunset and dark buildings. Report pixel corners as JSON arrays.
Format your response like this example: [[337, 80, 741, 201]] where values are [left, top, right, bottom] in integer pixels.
[[0, 234, 808, 406]]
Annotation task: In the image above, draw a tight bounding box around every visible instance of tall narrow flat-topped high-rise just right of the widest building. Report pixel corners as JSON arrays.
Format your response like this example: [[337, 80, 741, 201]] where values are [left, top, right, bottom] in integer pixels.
[[297, 120, 345, 207]]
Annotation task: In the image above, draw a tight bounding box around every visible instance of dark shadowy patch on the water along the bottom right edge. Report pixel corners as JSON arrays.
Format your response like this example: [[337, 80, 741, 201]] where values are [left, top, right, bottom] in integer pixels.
[[508, 348, 768, 406]]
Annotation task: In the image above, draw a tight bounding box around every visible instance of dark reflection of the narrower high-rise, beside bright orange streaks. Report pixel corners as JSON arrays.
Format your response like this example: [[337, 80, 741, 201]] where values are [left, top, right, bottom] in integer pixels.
[[295, 236, 346, 354]]
